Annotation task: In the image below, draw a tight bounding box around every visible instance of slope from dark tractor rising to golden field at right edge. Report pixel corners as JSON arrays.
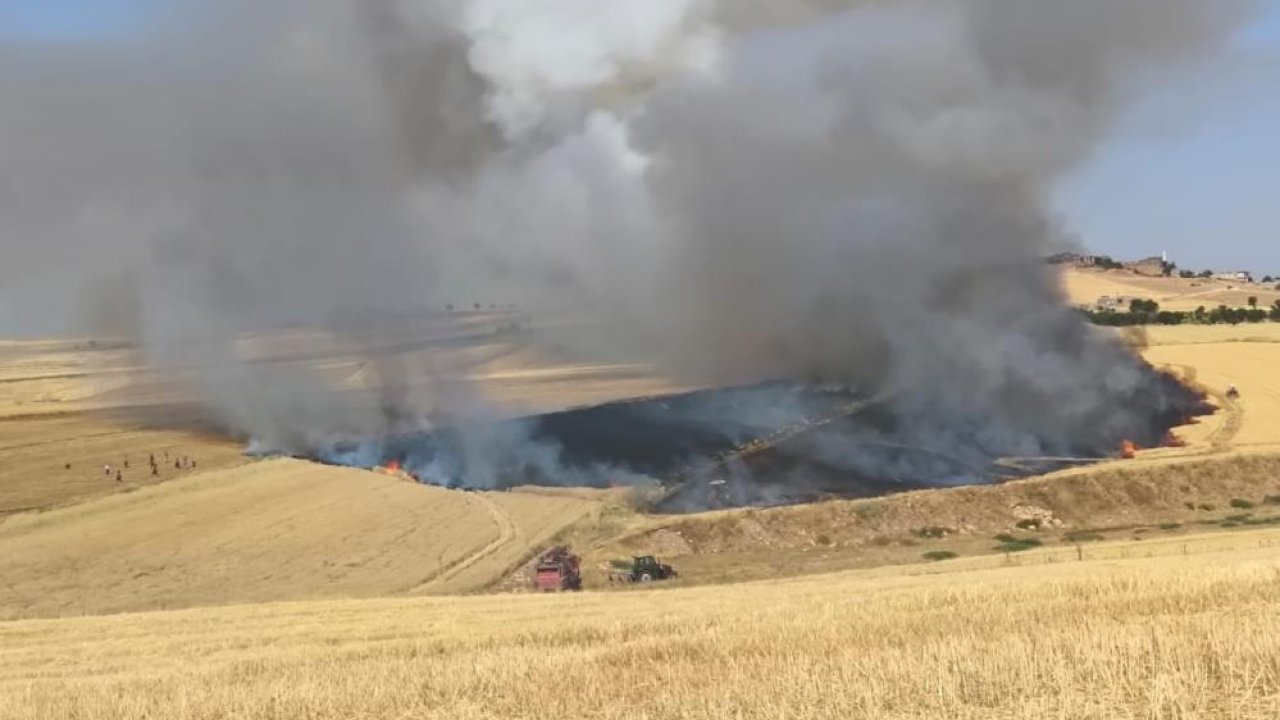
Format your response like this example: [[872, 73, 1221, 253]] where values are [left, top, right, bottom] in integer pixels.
[[586, 324, 1280, 587]]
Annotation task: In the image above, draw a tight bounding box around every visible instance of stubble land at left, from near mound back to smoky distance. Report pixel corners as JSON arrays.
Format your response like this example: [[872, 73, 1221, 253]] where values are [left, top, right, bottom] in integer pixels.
[[0, 322, 676, 618]]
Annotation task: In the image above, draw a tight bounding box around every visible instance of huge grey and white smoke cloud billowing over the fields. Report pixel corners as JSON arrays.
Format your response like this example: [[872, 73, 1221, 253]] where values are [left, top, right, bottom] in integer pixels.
[[0, 0, 1253, 476]]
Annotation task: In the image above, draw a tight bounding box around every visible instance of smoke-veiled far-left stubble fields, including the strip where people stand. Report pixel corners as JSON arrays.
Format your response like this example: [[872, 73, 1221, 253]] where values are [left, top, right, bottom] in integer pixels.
[[0, 320, 686, 518]]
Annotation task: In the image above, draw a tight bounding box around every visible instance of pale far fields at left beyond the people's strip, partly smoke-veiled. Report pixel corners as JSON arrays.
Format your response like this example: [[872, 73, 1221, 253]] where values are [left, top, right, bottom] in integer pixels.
[[0, 313, 689, 418]]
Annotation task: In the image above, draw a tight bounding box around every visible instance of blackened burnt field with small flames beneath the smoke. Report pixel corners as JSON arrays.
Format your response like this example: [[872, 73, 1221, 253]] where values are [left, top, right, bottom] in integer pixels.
[[316, 374, 1213, 512]]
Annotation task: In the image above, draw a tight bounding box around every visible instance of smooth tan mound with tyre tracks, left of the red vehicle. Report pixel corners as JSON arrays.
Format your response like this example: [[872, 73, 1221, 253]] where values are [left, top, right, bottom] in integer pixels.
[[0, 460, 595, 618]]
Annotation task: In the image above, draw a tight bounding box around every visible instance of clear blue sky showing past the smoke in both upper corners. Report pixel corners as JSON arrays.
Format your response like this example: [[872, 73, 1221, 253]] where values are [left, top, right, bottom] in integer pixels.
[[0, 0, 1280, 275]]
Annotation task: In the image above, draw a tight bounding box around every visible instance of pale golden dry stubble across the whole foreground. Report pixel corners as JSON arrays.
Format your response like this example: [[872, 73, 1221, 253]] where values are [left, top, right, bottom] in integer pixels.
[[0, 530, 1280, 720]]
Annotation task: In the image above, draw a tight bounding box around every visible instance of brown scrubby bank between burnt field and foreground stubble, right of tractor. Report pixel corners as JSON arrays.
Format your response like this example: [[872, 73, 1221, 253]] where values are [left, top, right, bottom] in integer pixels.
[[581, 454, 1280, 587]]
